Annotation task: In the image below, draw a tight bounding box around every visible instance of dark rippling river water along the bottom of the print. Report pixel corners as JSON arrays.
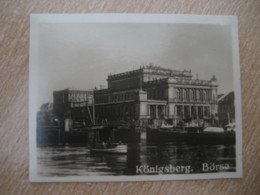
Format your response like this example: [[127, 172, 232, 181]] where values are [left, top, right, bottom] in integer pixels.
[[37, 140, 236, 177]]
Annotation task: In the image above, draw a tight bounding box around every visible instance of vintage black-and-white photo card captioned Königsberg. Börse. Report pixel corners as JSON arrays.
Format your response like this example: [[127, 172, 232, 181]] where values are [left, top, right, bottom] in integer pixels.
[[29, 14, 242, 182]]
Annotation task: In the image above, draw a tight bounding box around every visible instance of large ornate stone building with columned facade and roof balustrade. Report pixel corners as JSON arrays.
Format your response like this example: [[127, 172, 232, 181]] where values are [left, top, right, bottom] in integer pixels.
[[94, 66, 218, 124]]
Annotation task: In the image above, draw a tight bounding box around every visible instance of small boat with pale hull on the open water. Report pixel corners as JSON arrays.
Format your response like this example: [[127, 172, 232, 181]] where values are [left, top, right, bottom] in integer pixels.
[[90, 143, 127, 154]]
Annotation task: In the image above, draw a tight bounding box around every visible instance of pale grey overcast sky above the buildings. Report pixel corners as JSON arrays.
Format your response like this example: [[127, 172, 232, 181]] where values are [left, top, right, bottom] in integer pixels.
[[38, 23, 233, 106]]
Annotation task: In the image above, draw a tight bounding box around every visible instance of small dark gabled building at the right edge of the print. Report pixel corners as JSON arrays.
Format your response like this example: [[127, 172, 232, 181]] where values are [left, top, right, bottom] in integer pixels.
[[218, 91, 235, 126]]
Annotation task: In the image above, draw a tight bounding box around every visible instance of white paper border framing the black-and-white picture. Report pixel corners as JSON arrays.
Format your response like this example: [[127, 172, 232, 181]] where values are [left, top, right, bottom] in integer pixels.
[[29, 14, 243, 182]]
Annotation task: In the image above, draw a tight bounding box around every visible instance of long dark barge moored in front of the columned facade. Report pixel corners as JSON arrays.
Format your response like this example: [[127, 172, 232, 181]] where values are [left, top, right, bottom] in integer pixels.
[[146, 127, 235, 145]]
